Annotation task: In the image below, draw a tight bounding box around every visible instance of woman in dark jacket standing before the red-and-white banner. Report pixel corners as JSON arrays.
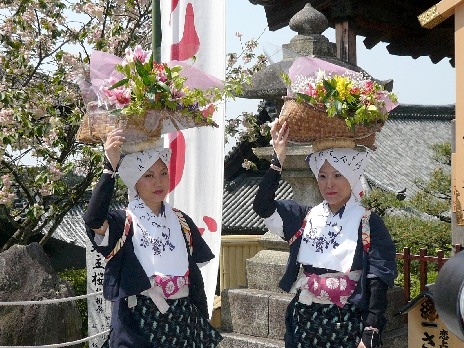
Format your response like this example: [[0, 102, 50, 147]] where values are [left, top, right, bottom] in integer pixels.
[[84, 130, 222, 348]]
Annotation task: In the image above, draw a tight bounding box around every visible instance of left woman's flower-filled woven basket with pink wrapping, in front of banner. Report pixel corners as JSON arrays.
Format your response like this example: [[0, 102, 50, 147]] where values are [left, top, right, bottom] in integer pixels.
[[77, 45, 227, 153]]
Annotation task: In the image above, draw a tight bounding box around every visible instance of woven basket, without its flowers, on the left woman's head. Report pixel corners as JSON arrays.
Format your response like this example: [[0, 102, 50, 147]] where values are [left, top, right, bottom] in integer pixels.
[[77, 102, 217, 154]]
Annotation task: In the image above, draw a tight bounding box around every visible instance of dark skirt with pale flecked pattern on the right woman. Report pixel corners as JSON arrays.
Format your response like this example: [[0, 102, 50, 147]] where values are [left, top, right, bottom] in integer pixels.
[[285, 299, 362, 348]]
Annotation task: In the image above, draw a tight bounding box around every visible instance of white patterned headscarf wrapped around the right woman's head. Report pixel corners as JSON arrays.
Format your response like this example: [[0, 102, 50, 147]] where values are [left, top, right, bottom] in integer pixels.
[[306, 148, 369, 202]]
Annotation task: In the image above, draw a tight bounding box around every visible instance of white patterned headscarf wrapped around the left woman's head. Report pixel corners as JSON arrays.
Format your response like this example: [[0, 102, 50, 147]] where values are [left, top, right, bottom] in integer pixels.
[[118, 147, 171, 202]]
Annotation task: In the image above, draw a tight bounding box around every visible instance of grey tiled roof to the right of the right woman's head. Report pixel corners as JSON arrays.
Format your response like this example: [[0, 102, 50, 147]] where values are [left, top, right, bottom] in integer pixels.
[[365, 105, 454, 197]]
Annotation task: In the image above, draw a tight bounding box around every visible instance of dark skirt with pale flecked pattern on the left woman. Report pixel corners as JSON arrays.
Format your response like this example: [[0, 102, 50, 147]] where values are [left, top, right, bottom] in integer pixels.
[[102, 295, 222, 348]]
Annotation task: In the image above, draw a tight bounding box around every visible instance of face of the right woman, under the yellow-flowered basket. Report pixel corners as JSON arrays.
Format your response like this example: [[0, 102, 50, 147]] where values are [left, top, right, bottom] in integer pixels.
[[317, 161, 351, 213]]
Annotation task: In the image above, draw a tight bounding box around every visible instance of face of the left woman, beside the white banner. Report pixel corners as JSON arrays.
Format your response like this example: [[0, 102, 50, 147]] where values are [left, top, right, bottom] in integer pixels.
[[135, 159, 169, 214]]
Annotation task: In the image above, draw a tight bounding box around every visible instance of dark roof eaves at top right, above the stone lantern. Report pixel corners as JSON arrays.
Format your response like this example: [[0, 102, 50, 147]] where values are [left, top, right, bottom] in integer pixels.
[[249, 0, 455, 66]]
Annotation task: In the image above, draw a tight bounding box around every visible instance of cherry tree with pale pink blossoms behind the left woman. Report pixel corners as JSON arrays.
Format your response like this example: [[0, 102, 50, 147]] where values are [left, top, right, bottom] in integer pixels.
[[0, 0, 266, 251]]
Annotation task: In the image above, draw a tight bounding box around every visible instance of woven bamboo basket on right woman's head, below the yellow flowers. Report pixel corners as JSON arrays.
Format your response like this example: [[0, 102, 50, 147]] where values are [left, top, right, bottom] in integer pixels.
[[279, 98, 384, 151]]
